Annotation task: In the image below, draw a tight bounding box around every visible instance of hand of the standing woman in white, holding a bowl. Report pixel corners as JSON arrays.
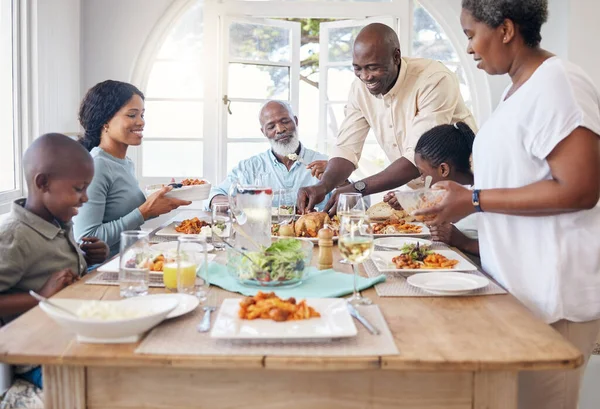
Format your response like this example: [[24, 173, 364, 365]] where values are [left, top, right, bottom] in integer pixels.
[[415, 181, 475, 226]]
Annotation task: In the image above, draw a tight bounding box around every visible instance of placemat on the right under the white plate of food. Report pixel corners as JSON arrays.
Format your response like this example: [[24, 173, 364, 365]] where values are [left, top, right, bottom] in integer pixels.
[[363, 260, 506, 297]]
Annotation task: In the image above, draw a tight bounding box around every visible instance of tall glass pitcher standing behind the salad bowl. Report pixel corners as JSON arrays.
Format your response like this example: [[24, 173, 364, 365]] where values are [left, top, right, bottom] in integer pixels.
[[228, 176, 273, 251]]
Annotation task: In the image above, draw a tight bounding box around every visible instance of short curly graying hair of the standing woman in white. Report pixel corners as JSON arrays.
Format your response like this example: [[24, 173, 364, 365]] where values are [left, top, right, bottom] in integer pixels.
[[462, 0, 548, 48]]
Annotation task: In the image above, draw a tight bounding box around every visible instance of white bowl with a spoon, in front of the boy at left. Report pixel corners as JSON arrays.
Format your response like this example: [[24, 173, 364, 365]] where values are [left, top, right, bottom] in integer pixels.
[[39, 297, 179, 343]]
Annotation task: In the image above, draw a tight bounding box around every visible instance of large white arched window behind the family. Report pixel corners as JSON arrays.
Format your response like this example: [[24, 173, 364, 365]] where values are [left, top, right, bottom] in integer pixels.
[[134, 0, 490, 187]]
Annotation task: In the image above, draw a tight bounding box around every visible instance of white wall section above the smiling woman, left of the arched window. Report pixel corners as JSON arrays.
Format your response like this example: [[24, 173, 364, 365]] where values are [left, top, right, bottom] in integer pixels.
[[81, 0, 173, 93]]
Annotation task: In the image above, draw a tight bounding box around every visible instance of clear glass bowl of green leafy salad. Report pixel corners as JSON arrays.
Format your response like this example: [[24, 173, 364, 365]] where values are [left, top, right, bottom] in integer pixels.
[[227, 238, 314, 287]]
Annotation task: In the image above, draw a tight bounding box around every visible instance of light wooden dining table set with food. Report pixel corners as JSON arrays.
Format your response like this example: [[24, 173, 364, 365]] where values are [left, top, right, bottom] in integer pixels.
[[0, 215, 583, 409]]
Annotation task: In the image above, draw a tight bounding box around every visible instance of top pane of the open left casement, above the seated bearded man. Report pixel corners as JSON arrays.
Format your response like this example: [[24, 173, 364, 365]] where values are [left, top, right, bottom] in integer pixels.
[[229, 23, 292, 62]]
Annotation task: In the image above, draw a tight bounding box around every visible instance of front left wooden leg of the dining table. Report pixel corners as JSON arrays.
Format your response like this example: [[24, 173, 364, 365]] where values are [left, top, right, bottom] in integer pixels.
[[42, 365, 86, 409]]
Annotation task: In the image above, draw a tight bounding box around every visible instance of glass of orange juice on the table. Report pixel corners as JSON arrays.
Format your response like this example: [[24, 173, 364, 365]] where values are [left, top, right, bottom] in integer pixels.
[[171, 235, 210, 301]]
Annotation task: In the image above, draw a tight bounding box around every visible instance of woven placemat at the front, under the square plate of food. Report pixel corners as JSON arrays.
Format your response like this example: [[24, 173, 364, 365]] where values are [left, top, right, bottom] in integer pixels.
[[135, 302, 399, 356]]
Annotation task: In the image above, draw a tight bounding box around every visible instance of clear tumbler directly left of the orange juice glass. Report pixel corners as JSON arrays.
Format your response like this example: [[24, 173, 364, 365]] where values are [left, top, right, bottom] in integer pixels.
[[119, 230, 152, 298]]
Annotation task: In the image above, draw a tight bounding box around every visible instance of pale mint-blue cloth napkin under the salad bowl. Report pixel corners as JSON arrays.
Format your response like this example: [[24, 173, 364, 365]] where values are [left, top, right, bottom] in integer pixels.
[[208, 263, 385, 298]]
